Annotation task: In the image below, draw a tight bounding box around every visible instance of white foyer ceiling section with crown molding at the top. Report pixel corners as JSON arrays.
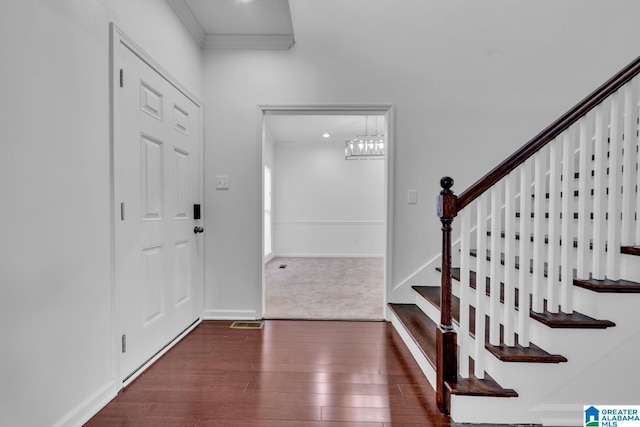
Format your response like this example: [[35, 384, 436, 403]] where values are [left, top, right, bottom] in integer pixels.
[[167, 0, 294, 49]]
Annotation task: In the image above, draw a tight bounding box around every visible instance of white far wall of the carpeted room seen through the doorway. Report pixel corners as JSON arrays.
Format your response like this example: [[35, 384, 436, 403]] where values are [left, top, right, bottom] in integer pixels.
[[275, 142, 385, 256]]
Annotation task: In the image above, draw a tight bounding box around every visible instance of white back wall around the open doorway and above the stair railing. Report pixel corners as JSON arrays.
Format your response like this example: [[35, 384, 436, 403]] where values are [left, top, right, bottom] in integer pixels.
[[204, 0, 640, 315]]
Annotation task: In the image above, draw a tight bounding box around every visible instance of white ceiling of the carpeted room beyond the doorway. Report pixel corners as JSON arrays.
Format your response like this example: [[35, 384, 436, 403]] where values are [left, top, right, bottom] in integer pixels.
[[265, 115, 385, 144]]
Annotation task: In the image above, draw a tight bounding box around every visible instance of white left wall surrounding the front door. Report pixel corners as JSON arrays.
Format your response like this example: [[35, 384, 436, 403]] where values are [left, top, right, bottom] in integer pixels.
[[0, 0, 202, 426]]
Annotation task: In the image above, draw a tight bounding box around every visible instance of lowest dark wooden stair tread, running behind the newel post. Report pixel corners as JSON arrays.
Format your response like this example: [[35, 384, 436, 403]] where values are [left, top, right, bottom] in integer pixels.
[[389, 303, 518, 397]]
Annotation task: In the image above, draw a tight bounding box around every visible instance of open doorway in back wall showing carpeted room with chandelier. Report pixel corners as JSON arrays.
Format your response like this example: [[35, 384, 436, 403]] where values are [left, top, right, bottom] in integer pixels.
[[260, 106, 393, 320]]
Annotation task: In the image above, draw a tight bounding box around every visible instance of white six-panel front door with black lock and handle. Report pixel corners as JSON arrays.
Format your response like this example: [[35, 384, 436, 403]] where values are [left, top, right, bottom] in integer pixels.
[[114, 38, 203, 380]]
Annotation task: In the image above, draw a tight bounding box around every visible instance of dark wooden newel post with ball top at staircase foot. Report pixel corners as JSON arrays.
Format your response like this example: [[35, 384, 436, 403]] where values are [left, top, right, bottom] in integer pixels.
[[436, 176, 458, 414]]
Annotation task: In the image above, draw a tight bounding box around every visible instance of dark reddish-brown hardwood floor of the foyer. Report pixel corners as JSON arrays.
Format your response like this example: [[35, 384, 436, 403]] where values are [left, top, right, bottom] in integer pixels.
[[86, 320, 450, 427]]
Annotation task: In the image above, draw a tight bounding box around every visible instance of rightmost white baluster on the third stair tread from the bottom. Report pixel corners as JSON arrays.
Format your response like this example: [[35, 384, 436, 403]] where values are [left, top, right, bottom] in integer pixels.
[[560, 126, 577, 314]]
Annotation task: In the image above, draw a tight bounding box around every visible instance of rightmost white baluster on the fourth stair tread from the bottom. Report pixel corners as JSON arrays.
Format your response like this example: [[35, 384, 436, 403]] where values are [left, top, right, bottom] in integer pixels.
[[606, 91, 623, 280]]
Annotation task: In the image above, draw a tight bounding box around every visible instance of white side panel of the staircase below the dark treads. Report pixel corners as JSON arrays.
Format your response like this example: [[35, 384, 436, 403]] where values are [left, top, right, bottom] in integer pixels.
[[415, 280, 640, 426]]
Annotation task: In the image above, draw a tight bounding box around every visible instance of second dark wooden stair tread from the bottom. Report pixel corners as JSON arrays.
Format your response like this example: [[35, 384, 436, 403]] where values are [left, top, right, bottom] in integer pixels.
[[413, 286, 567, 363]]
